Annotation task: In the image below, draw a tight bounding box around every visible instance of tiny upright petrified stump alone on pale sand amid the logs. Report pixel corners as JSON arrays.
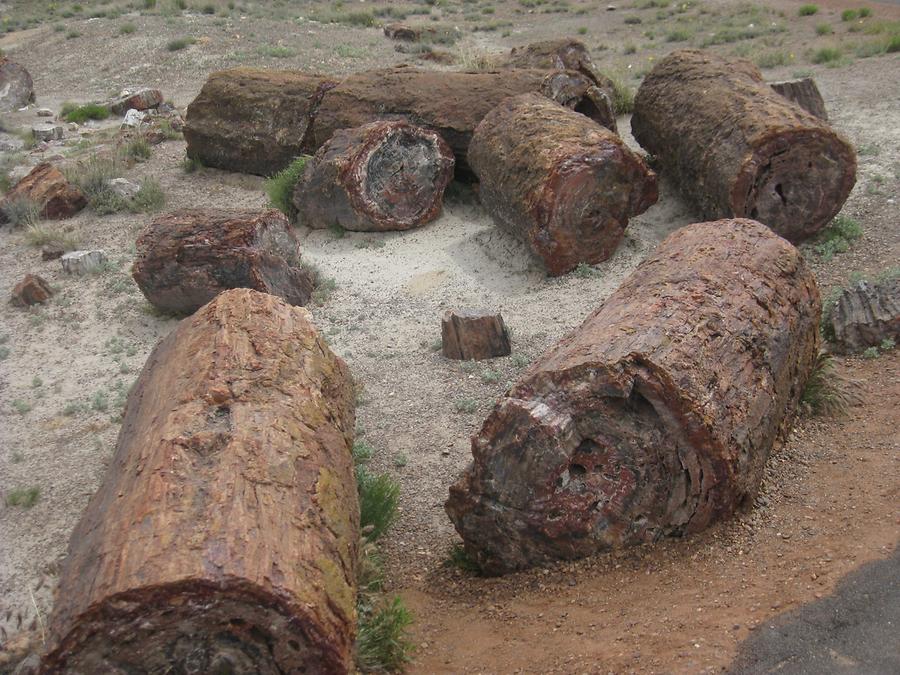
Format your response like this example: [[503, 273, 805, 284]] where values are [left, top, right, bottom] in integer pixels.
[[441, 310, 512, 361]]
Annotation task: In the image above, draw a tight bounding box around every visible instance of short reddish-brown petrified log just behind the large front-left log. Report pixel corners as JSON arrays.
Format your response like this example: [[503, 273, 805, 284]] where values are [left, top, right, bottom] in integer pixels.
[[131, 209, 314, 313]]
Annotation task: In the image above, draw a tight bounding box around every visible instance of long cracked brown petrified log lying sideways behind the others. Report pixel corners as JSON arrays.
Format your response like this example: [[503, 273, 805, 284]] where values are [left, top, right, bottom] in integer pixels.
[[184, 67, 616, 177]]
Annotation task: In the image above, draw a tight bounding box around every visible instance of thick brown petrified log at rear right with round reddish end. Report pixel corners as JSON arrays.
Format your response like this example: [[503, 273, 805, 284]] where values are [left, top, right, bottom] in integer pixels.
[[631, 49, 856, 243]]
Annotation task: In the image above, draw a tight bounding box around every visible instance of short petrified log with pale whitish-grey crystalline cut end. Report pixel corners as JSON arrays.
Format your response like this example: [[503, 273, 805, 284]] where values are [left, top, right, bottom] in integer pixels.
[[293, 121, 453, 232]]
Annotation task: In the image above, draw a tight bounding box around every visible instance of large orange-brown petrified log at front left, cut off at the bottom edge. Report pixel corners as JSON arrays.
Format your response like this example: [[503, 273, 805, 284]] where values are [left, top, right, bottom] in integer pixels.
[[43, 289, 359, 673]]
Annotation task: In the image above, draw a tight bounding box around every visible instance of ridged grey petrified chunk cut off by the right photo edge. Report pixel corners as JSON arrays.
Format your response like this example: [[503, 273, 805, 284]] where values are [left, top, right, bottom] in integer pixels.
[[830, 277, 900, 352]]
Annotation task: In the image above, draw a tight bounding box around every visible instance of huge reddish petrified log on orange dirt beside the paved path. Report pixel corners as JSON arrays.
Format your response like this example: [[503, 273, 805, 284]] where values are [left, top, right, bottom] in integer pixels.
[[446, 220, 821, 573]]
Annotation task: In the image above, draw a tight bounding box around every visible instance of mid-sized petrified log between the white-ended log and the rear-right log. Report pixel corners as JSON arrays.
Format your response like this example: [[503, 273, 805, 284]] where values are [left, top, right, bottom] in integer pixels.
[[469, 94, 657, 275]]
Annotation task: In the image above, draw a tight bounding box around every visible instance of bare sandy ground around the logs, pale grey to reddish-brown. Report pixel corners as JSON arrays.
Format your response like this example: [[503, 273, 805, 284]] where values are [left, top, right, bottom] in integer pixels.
[[0, 0, 900, 673]]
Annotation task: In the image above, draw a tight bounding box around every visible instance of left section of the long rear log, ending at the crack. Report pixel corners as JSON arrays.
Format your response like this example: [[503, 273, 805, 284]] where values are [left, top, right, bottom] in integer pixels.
[[184, 68, 335, 175]]
